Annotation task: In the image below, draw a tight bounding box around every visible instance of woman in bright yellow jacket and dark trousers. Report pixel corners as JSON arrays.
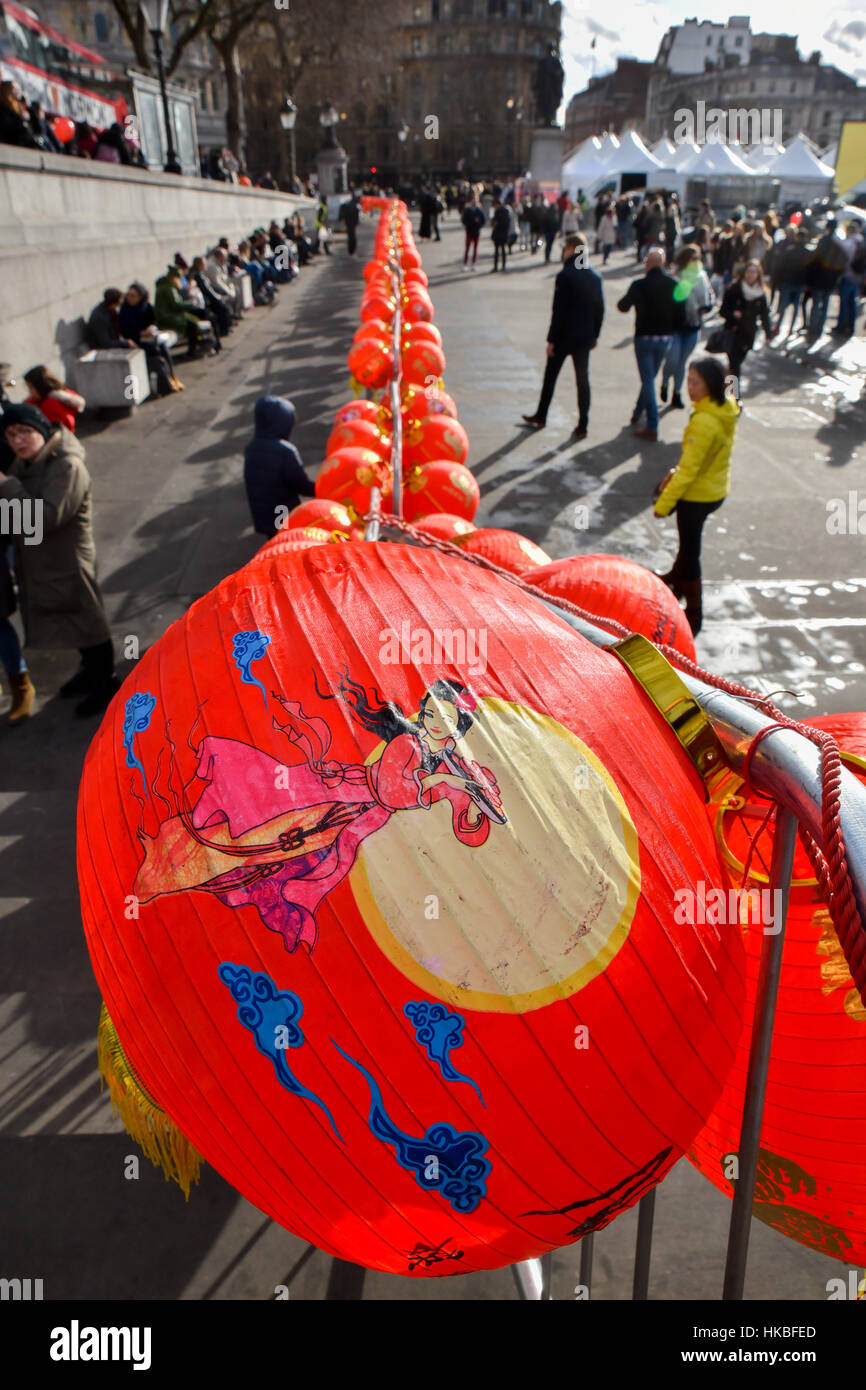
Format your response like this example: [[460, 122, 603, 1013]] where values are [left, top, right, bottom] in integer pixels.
[[655, 357, 740, 635]]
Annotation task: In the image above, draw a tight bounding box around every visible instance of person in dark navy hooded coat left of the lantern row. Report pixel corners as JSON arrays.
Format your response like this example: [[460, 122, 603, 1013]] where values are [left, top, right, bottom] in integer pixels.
[[243, 396, 316, 537]]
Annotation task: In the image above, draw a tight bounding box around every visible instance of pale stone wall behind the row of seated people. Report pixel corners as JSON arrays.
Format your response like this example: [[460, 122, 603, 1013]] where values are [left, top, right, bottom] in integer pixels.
[[0, 145, 316, 383]]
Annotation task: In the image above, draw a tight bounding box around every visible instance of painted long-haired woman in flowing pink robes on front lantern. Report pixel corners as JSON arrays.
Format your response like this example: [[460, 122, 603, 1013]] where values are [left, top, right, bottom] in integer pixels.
[[135, 673, 506, 951]]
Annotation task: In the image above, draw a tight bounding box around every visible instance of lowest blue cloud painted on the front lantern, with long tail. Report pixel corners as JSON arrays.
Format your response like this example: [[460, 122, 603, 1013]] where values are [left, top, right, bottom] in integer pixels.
[[331, 1038, 491, 1213]]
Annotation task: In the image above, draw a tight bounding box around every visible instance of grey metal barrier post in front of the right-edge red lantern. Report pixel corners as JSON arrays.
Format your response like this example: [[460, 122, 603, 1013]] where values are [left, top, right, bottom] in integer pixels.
[[721, 806, 796, 1301]]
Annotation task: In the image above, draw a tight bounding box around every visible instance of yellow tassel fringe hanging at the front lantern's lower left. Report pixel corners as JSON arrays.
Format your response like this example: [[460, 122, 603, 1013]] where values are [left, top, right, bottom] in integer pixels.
[[96, 1004, 202, 1201]]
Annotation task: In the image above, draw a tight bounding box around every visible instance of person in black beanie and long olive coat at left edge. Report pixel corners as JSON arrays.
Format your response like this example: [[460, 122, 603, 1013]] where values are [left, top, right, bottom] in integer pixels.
[[0, 404, 120, 719]]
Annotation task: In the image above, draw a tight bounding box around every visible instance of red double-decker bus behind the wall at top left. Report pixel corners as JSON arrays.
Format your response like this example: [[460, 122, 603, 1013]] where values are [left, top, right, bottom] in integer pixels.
[[0, 0, 128, 129]]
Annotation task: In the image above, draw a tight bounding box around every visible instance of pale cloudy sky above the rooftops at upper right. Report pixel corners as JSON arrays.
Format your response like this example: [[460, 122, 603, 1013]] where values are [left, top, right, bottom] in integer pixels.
[[562, 0, 866, 101]]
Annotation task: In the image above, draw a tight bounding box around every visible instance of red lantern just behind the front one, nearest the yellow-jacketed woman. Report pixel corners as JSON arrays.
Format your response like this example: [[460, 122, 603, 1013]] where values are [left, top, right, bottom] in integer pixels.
[[524, 555, 696, 662]]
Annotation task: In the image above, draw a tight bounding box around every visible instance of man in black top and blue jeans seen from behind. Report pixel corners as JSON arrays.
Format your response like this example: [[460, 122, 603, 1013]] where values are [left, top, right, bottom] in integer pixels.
[[617, 246, 685, 439]]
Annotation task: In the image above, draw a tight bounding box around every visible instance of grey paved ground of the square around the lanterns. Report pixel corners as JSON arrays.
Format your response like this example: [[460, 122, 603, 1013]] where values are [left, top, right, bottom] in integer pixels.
[[0, 218, 866, 1300]]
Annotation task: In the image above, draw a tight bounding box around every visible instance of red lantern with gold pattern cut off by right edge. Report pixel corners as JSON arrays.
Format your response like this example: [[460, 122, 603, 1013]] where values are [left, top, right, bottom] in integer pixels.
[[688, 714, 866, 1265]]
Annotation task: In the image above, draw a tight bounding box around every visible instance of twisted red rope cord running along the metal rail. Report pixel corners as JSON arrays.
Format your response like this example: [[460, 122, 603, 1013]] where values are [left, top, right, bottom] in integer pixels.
[[364, 513, 866, 1004]]
